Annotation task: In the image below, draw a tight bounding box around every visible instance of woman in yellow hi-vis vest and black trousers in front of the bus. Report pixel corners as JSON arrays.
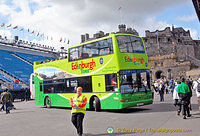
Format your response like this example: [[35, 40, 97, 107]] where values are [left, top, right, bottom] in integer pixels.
[[70, 87, 87, 136]]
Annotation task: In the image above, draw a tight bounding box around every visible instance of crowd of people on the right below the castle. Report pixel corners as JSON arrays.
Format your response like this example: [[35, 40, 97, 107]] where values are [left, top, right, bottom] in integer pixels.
[[152, 76, 200, 119]]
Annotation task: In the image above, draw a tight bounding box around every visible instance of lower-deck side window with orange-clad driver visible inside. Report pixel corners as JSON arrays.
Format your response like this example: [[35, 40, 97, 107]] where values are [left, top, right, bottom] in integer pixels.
[[105, 73, 118, 92]]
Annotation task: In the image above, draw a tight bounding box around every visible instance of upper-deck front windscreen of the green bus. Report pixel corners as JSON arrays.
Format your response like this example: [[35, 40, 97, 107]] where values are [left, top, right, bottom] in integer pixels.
[[117, 35, 145, 53]]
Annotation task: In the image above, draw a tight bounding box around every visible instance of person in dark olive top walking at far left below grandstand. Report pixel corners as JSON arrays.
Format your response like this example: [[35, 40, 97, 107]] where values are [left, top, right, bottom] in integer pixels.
[[2, 89, 12, 114]]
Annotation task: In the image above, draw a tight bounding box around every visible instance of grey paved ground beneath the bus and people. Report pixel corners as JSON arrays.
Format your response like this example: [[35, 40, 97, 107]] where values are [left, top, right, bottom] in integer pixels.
[[0, 94, 200, 136]]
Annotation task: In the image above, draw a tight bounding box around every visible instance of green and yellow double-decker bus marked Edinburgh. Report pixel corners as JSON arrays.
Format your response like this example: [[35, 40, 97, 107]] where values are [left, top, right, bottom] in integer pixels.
[[34, 34, 153, 111]]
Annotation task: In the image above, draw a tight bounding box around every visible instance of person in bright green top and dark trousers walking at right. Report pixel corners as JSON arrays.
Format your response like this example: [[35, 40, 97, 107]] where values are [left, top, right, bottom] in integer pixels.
[[178, 78, 191, 119]]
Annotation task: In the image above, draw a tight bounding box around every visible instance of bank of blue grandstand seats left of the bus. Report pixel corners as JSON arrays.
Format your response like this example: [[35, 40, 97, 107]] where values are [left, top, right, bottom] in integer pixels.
[[0, 47, 57, 90]]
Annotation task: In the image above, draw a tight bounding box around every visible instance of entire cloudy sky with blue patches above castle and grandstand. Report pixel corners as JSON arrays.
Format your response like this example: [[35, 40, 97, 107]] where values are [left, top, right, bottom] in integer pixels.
[[0, 0, 200, 48]]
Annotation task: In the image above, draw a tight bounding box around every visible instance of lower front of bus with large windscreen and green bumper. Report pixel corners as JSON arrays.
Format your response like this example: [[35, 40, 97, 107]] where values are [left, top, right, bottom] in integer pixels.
[[119, 70, 153, 109]]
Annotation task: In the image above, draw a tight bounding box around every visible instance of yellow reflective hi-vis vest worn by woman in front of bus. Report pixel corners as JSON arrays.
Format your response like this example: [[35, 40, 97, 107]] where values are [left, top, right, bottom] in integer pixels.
[[71, 94, 86, 114]]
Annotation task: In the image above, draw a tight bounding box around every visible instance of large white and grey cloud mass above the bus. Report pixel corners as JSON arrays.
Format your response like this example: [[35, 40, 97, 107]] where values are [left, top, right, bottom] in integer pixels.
[[0, 0, 192, 48]]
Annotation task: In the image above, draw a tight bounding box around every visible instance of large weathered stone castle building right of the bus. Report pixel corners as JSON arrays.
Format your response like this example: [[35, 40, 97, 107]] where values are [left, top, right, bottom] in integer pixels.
[[143, 26, 200, 80]]
